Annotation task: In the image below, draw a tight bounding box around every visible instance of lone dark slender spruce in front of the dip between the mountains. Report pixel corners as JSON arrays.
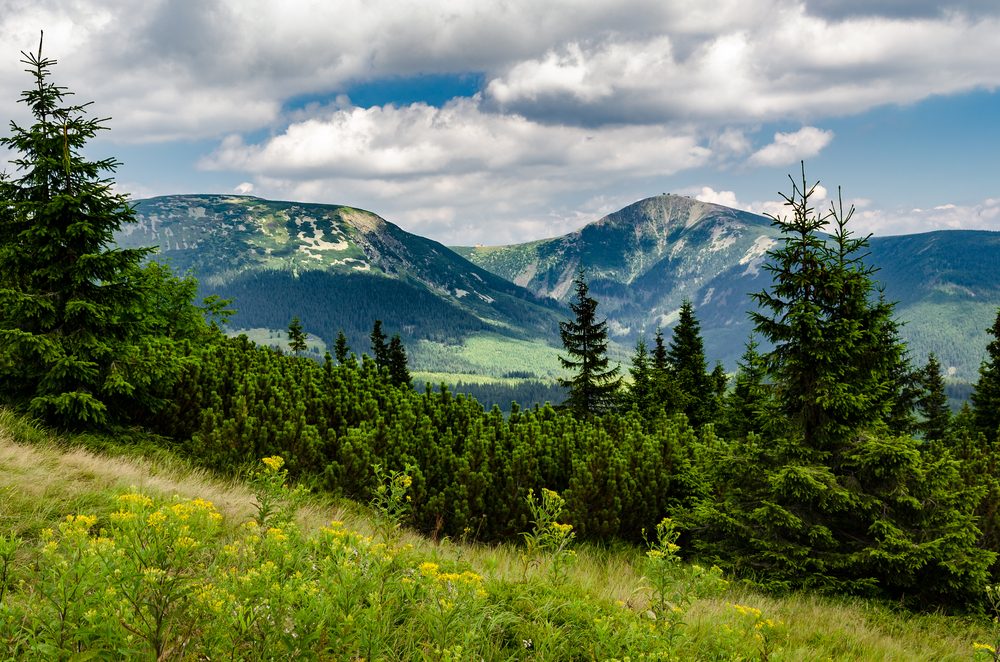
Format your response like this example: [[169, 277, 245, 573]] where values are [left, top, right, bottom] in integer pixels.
[[559, 270, 622, 415]]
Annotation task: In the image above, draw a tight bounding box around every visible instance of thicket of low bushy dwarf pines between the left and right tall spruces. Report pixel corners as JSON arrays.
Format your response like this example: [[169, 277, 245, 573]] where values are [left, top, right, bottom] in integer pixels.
[[145, 338, 703, 539]]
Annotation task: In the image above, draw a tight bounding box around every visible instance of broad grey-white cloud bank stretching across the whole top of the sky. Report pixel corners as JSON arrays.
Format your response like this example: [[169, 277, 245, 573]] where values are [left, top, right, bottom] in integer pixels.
[[0, 0, 1000, 140]]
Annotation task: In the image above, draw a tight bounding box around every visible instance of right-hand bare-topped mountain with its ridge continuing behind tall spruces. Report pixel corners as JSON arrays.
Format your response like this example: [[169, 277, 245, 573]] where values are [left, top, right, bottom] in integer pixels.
[[456, 195, 1000, 382]]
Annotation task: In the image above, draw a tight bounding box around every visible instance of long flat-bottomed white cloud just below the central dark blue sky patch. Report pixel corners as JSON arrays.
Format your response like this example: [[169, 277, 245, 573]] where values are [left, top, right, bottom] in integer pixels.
[[204, 99, 709, 178]]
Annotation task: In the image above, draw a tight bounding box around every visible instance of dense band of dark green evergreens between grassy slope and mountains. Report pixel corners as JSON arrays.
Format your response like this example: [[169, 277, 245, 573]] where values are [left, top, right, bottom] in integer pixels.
[[0, 40, 1000, 608]]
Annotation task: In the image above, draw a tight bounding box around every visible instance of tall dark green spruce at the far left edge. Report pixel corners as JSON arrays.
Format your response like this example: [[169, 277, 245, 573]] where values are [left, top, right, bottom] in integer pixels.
[[0, 37, 162, 428]]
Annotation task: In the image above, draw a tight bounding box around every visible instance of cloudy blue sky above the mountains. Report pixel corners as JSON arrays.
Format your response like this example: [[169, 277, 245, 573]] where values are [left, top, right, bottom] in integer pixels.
[[0, 0, 1000, 245]]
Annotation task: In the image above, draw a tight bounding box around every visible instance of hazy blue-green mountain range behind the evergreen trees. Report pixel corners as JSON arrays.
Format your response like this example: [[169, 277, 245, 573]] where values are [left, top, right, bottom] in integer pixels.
[[118, 195, 1000, 382]]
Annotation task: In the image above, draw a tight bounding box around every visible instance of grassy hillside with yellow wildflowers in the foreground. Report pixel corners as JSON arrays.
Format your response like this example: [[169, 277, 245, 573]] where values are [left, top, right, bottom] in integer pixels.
[[0, 410, 995, 661]]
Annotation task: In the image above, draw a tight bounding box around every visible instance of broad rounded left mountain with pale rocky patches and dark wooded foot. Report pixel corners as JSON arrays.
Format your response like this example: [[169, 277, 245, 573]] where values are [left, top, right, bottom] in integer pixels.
[[118, 195, 562, 368]]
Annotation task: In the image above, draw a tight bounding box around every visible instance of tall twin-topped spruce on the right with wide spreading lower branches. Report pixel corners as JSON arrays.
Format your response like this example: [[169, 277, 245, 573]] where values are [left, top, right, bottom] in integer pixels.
[[678, 168, 993, 603]]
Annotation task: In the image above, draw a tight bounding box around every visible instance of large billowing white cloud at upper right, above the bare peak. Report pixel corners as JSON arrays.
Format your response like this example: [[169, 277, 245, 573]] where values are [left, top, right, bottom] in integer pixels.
[[486, 8, 1000, 123]]
